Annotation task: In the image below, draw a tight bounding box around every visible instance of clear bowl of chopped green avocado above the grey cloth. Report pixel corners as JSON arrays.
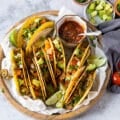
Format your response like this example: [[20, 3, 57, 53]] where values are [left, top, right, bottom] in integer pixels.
[[86, 0, 115, 26]]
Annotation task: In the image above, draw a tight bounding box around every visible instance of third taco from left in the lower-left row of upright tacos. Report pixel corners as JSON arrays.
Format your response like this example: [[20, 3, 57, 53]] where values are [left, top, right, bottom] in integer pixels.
[[33, 47, 56, 98]]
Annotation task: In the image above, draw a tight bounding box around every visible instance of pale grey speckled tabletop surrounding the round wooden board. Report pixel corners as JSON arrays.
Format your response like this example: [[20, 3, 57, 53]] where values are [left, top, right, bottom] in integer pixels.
[[0, 0, 120, 120]]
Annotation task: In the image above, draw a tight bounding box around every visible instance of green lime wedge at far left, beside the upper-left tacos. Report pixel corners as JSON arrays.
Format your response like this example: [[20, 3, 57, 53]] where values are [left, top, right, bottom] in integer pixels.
[[9, 29, 17, 47]]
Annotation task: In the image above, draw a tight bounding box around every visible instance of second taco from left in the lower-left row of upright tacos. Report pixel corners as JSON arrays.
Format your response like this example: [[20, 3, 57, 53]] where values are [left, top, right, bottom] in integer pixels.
[[25, 54, 46, 100]]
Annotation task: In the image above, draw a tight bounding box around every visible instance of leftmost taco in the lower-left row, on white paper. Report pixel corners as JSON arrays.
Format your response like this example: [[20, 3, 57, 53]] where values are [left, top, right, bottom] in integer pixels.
[[10, 49, 30, 96]]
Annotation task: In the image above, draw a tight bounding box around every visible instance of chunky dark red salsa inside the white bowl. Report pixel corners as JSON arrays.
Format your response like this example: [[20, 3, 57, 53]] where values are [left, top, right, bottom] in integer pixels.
[[58, 21, 84, 43]]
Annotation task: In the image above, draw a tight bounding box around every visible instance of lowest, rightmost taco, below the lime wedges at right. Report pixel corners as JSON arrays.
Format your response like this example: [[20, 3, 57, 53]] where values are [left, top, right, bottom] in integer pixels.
[[64, 71, 96, 109]]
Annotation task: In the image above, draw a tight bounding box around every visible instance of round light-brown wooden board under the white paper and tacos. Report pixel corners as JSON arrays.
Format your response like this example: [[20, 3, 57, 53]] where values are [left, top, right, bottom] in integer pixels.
[[0, 11, 111, 120]]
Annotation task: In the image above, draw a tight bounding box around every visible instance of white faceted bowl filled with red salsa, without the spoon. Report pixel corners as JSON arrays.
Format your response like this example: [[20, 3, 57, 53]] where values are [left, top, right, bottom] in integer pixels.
[[56, 15, 87, 47]]
